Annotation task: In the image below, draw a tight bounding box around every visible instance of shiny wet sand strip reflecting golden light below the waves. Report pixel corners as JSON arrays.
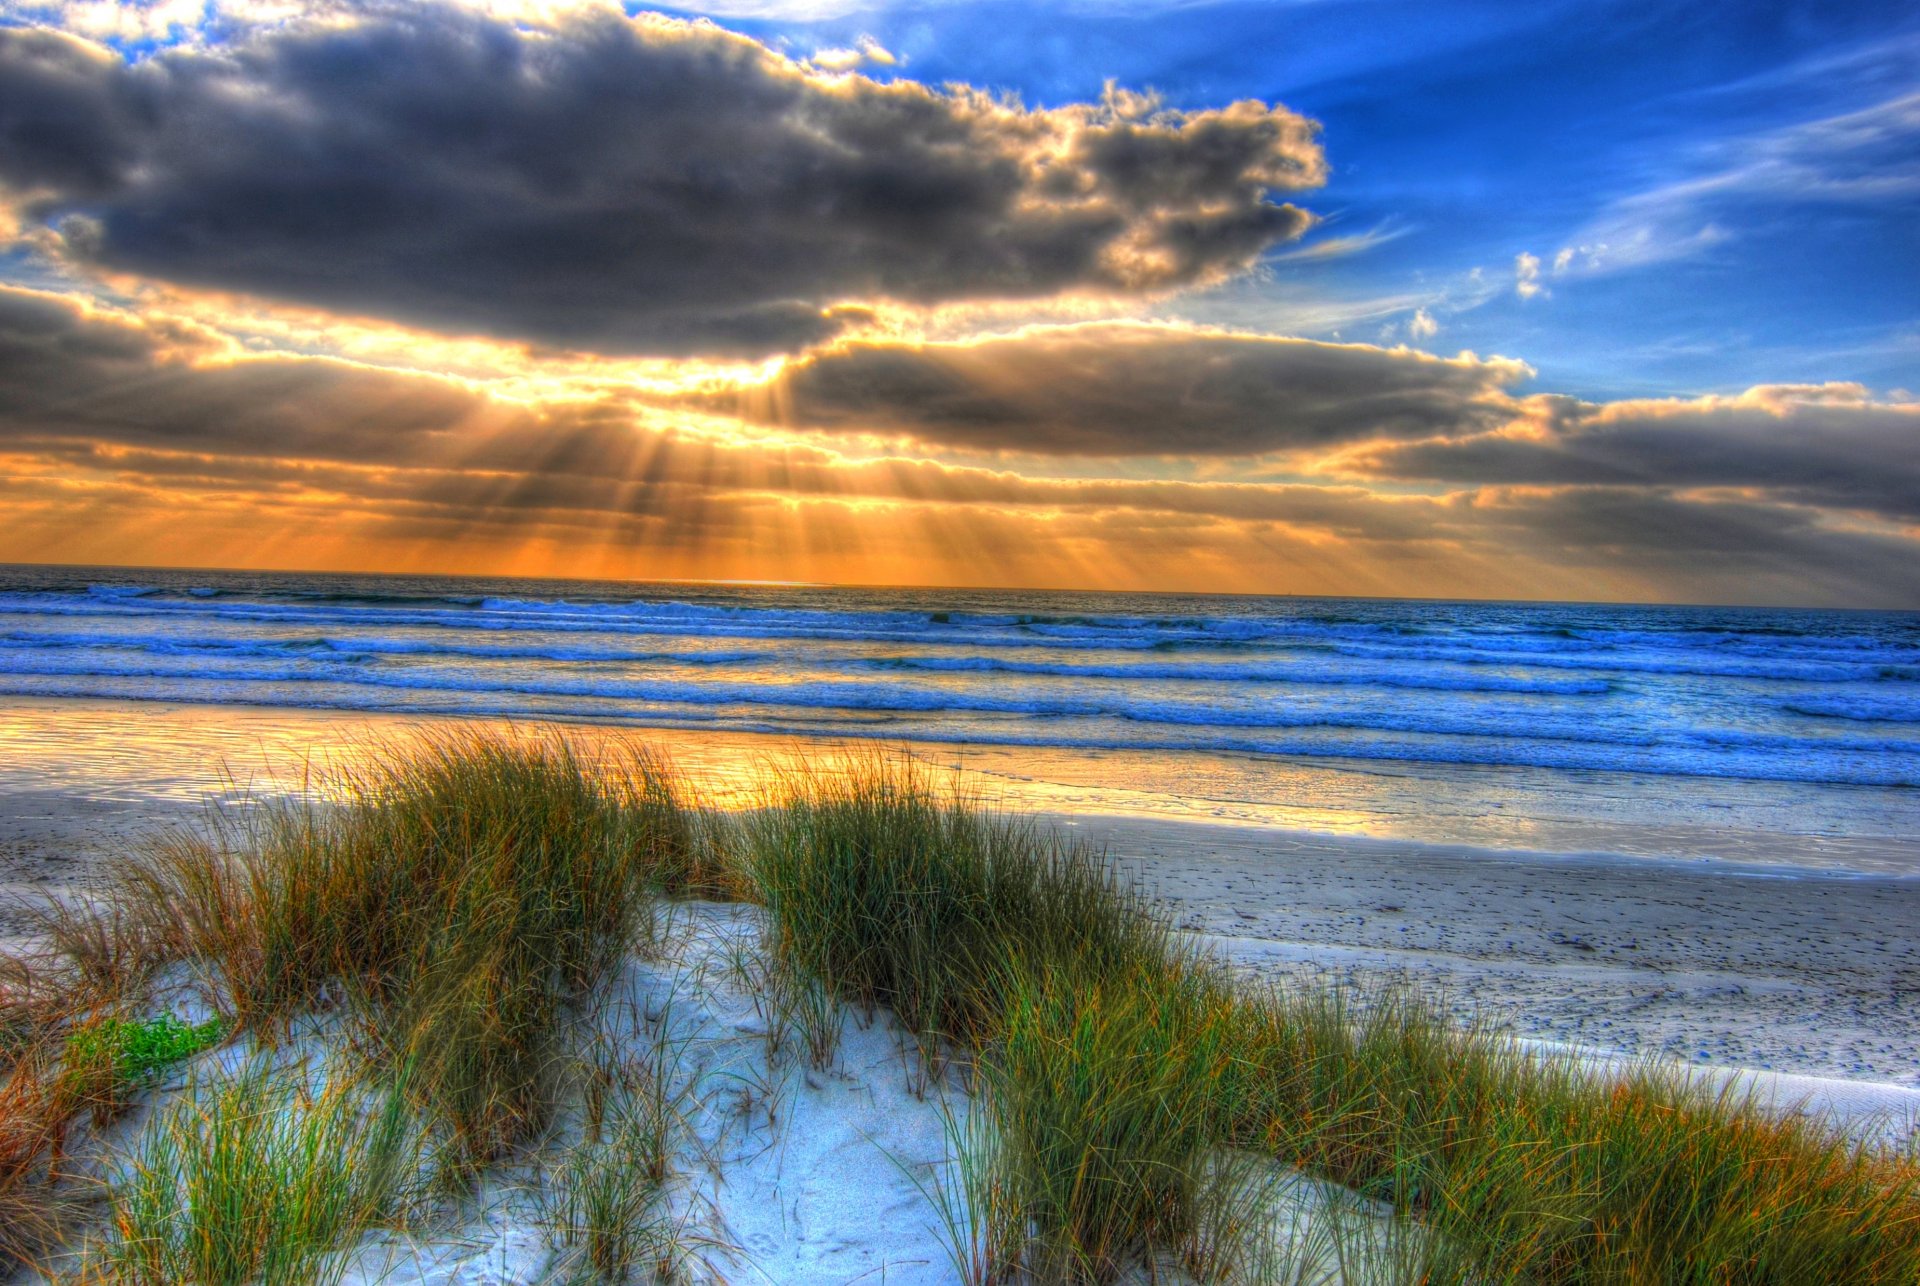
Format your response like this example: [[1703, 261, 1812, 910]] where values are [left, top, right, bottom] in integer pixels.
[[0, 697, 1920, 877]]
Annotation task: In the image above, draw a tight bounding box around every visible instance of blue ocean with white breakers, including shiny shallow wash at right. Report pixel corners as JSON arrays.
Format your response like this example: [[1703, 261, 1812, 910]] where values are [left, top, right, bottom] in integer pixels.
[[0, 566, 1920, 869]]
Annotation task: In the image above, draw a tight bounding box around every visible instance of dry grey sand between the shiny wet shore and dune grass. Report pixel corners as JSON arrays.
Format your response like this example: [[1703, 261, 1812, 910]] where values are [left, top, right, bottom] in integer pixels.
[[0, 771, 1920, 1090]]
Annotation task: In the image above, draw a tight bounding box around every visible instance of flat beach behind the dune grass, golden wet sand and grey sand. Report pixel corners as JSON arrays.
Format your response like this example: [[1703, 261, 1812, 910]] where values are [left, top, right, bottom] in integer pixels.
[[0, 701, 1920, 1088]]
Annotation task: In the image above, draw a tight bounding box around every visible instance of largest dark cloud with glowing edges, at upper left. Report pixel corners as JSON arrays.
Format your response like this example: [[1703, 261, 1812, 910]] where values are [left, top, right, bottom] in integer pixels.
[[0, 4, 1323, 353]]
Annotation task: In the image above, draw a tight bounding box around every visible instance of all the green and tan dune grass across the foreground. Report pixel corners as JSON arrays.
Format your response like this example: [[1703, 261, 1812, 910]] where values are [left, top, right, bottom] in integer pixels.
[[0, 733, 1920, 1286]]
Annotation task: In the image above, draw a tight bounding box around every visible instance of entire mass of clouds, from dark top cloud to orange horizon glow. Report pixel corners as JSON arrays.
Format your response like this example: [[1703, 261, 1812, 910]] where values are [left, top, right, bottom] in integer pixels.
[[0, 0, 1920, 607]]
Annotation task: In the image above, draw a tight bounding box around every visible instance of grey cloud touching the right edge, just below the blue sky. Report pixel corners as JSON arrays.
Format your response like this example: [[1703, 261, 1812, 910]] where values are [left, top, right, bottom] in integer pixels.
[[1350, 386, 1920, 520]]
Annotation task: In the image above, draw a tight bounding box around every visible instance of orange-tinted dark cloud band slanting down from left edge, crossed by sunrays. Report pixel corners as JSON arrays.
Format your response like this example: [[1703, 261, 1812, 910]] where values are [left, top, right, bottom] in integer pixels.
[[0, 288, 1443, 537]]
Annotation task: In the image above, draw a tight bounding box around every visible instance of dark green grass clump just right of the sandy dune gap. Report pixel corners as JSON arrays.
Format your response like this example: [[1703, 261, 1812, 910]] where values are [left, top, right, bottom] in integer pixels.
[[747, 754, 1171, 1048]]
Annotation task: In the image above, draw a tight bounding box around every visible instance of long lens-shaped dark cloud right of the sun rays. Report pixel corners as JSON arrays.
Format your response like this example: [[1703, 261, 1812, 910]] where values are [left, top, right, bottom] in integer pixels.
[[701, 322, 1528, 455]]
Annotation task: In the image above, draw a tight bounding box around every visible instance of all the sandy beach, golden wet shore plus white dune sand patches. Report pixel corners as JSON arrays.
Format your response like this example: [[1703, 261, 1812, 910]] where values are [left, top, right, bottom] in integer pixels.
[[0, 701, 1920, 1286]]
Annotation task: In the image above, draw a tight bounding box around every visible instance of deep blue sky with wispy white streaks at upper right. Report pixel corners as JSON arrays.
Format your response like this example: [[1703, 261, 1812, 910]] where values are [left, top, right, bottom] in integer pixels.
[[664, 0, 1920, 397]]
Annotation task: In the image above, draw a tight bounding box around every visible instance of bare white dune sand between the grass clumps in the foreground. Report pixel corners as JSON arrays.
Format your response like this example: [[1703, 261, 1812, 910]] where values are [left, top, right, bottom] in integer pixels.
[[332, 904, 964, 1286]]
